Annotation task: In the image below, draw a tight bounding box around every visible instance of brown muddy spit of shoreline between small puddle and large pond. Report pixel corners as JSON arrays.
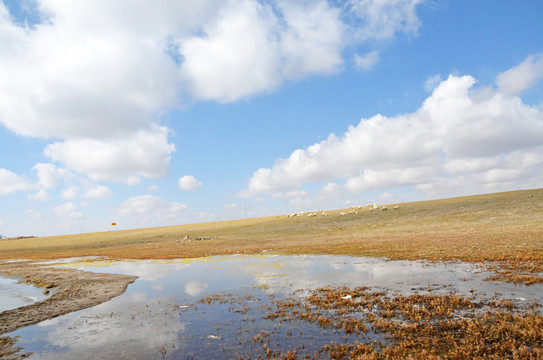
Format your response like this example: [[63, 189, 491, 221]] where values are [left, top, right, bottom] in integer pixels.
[[0, 262, 137, 335]]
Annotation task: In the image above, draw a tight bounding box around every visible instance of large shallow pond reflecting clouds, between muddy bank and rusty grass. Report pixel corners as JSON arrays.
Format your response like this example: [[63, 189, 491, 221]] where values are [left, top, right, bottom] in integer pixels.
[[5, 256, 543, 359]]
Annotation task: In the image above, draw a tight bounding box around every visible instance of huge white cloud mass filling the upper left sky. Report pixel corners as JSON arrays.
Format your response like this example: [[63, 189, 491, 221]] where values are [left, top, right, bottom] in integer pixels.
[[0, 0, 428, 184]]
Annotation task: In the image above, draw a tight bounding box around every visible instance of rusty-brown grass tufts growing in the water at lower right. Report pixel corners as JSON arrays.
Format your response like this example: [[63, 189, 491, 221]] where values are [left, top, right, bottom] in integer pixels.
[[266, 288, 543, 359]]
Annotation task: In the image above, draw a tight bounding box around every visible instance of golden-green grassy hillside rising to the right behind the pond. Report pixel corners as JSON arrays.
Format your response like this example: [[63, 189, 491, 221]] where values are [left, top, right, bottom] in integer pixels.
[[0, 189, 543, 263]]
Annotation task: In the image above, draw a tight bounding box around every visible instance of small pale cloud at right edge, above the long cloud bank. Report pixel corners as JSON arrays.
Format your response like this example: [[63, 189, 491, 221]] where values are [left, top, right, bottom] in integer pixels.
[[496, 54, 543, 95]]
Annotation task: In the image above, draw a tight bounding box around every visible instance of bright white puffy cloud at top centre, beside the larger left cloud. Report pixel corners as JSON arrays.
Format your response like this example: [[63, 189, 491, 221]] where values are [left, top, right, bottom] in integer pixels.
[[180, 1, 343, 102]]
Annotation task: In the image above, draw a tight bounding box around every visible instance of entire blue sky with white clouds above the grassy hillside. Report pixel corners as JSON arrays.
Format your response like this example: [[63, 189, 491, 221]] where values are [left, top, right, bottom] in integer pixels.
[[0, 0, 543, 236]]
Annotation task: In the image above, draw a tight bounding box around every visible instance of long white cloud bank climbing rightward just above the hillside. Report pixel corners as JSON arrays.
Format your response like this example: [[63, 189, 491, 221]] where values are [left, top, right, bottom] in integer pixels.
[[238, 57, 543, 197]]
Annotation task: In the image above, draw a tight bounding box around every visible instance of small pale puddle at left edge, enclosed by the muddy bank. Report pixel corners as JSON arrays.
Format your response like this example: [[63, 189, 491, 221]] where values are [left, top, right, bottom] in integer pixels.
[[0, 277, 50, 312]]
